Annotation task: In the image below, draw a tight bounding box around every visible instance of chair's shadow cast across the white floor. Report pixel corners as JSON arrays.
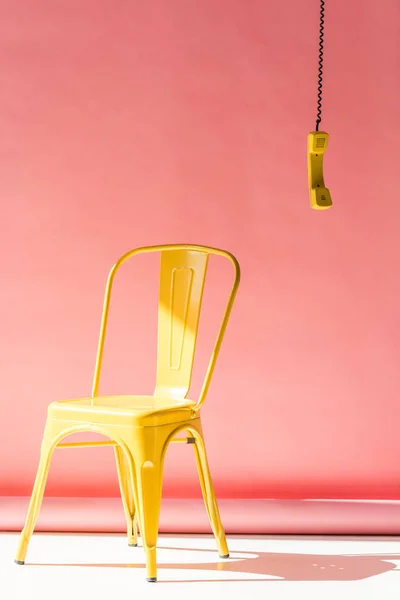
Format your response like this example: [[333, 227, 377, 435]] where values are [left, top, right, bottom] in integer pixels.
[[27, 547, 400, 584]]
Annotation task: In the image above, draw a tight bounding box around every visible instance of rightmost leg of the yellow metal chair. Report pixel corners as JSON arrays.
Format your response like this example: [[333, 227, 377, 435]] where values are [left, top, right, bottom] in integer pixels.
[[194, 432, 229, 558]]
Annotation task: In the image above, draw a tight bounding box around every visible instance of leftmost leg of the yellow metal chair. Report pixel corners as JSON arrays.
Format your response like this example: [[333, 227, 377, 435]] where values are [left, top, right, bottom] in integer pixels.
[[15, 425, 53, 565]]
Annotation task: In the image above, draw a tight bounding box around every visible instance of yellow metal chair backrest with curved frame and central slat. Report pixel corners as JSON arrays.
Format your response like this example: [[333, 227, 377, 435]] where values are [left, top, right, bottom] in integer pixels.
[[92, 244, 240, 410]]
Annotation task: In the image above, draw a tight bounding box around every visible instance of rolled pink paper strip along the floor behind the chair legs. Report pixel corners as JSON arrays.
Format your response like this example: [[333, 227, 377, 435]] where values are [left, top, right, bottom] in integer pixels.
[[4, 496, 400, 535]]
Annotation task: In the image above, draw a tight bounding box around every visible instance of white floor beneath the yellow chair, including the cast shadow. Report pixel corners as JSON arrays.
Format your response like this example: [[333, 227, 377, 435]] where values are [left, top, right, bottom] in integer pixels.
[[0, 533, 400, 600]]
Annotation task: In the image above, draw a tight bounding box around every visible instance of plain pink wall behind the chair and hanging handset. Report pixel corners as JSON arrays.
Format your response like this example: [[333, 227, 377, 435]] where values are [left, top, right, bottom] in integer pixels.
[[0, 0, 400, 498]]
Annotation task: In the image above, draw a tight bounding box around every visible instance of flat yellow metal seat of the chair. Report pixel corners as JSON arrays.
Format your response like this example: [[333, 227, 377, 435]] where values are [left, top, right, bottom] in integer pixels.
[[48, 396, 196, 426]]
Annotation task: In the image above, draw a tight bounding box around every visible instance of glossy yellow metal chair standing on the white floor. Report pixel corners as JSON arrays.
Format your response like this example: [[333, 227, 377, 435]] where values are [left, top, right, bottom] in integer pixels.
[[15, 244, 240, 581]]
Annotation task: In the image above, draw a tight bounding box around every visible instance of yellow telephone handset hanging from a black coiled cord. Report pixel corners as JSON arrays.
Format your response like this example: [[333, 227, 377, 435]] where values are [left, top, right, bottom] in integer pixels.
[[307, 131, 332, 210]]
